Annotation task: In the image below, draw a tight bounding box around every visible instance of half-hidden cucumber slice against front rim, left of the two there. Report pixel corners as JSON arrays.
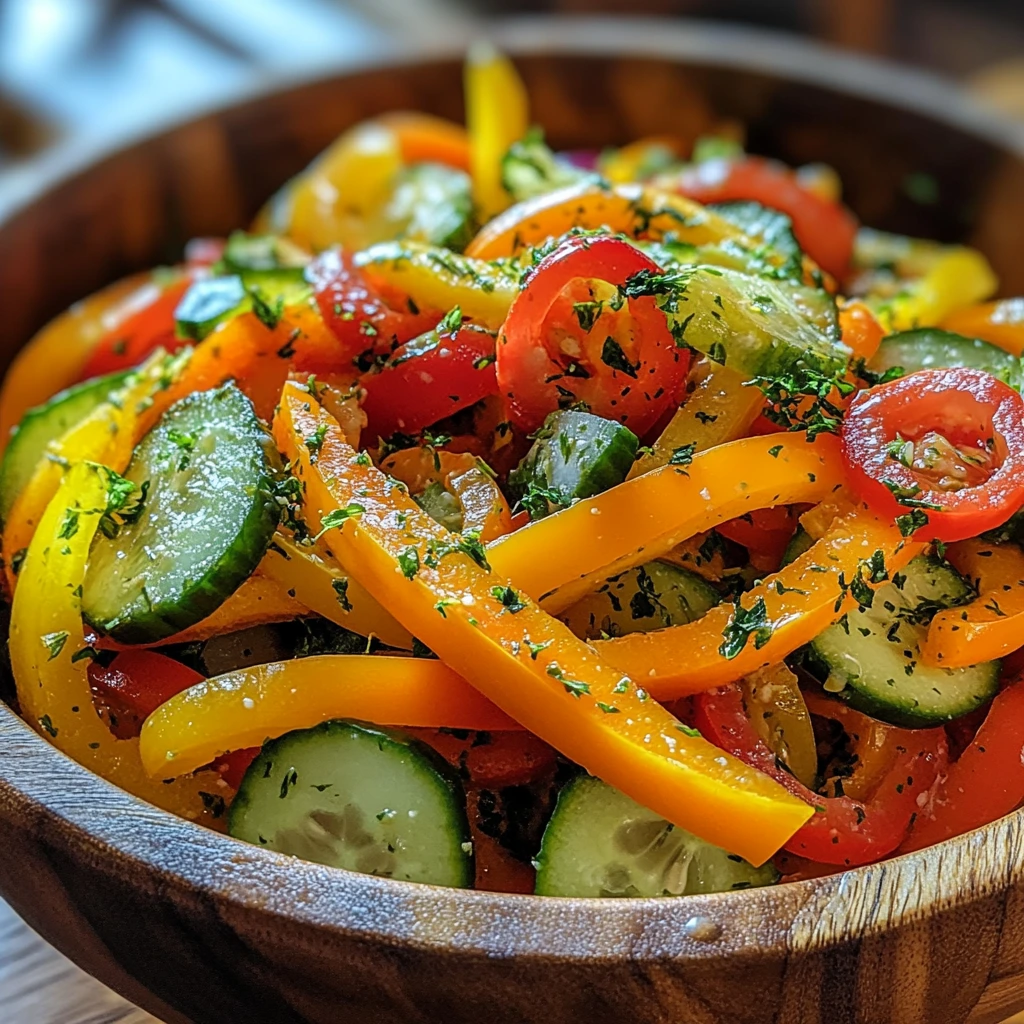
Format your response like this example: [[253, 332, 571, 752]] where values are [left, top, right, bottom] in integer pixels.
[[227, 720, 473, 888]]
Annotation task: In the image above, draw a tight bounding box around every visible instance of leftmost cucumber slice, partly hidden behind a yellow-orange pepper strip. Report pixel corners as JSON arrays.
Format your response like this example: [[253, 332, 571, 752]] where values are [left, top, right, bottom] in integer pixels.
[[0, 371, 129, 519]]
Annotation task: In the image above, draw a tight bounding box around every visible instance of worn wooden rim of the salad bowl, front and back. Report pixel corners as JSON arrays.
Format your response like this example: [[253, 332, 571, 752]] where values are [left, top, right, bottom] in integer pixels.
[[0, 17, 1024, 965]]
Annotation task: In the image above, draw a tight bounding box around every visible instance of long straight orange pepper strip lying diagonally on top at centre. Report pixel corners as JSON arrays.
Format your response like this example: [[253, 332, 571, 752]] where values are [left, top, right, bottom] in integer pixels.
[[274, 385, 812, 863]]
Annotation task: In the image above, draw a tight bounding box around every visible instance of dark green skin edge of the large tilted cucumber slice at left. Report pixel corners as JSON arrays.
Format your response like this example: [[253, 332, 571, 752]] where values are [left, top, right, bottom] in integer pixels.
[[83, 384, 281, 644]]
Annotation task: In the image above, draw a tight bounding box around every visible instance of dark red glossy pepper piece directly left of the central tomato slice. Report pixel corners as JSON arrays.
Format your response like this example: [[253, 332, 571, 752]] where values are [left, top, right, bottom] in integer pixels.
[[359, 324, 498, 438]]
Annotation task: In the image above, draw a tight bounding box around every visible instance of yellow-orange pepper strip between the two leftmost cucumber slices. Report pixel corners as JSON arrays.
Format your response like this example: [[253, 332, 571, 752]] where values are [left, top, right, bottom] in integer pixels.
[[3, 351, 188, 593]]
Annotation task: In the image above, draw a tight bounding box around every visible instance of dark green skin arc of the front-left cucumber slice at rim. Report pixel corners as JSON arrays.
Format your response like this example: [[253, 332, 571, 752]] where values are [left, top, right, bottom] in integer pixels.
[[226, 719, 475, 889]]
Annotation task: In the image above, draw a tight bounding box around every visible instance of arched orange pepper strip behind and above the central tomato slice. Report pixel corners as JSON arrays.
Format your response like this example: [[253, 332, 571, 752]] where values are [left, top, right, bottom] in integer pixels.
[[466, 183, 754, 260]]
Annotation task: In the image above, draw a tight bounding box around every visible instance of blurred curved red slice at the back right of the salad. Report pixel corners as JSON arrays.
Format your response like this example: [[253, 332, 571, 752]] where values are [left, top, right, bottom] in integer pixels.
[[677, 157, 857, 280]]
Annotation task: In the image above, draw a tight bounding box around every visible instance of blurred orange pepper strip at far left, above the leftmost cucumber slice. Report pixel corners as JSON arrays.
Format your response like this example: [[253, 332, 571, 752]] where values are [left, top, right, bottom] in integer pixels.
[[0, 271, 174, 442]]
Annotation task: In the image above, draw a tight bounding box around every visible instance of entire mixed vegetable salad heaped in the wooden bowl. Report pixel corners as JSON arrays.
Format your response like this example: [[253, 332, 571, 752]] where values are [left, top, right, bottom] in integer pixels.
[[0, 49, 1024, 897]]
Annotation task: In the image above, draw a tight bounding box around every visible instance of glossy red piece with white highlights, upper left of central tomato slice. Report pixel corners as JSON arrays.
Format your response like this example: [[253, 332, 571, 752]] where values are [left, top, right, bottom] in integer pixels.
[[306, 247, 446, 372]]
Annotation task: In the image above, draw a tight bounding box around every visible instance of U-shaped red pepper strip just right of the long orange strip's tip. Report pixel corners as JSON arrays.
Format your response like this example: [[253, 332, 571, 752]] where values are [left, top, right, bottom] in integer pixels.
[[693, 684, 946, 867]]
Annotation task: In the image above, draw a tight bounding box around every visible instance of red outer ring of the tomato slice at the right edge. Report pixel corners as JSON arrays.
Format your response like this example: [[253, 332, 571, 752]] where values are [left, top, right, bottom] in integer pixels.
[[843, 367, 1024, 542]]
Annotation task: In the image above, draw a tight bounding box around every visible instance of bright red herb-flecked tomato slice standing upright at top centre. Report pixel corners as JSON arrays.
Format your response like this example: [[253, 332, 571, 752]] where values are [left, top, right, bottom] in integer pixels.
[[498, 236, 690, 436]]
